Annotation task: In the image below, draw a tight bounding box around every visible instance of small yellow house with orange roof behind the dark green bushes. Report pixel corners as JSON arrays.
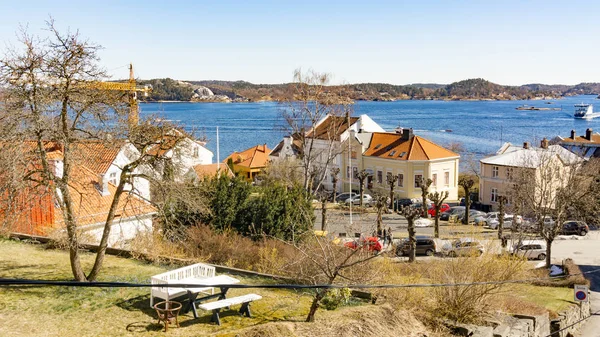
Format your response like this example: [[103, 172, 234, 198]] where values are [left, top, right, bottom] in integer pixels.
[[223, 144, 271, 182]]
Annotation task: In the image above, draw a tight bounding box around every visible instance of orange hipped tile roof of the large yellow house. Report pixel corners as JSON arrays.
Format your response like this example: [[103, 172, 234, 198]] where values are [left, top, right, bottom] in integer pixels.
[[364, 132, 459, 160]]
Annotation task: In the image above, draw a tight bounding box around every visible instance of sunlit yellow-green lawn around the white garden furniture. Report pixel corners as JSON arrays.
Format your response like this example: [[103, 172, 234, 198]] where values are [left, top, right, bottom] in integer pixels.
[[0, 240, 311, 336]]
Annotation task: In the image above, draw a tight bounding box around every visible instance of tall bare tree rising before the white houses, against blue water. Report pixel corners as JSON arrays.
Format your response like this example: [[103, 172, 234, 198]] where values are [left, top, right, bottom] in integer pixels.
[[282, 69, 352, 191]]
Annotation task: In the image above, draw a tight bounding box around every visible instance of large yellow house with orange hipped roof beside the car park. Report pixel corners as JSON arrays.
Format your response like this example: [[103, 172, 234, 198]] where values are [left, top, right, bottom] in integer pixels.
[[342, 129, 460, 201]]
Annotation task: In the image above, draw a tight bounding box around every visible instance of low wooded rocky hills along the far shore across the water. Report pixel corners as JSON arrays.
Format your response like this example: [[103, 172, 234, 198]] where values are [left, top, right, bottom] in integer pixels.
[[139, 78, 600, 103]]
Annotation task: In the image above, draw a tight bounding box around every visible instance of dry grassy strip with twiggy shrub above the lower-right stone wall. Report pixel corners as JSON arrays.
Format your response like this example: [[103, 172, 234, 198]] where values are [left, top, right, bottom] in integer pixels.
[[378, 254, 572, 325]]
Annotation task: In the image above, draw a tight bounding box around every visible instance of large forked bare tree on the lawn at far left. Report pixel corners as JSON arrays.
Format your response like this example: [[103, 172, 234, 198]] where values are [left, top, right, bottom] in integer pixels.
[[0, 21, 185, 281]]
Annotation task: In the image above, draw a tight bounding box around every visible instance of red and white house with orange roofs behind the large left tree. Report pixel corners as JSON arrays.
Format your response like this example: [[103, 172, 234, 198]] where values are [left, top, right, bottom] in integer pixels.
[[0, 142, 156, 247]]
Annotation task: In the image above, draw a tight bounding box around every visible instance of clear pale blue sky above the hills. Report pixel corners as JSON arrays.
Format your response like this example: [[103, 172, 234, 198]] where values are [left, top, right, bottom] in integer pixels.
[[0, 0, 600, 85]]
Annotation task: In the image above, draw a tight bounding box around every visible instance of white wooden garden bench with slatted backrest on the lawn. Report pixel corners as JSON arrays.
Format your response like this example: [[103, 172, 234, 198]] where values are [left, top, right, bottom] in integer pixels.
[[150, 263, 215, 307]]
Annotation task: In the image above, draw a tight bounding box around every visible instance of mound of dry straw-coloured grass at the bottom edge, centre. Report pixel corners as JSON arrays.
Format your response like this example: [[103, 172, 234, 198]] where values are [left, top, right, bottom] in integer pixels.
[[236, 305, 448, 337]]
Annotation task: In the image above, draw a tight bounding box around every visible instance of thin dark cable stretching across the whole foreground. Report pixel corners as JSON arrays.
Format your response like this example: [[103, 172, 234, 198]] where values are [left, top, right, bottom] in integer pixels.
[[0, 268, 600, 289]]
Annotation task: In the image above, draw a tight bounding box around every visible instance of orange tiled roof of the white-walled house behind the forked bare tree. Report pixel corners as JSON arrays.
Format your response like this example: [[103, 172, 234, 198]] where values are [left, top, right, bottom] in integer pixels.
[[54, 165, 156, 226]]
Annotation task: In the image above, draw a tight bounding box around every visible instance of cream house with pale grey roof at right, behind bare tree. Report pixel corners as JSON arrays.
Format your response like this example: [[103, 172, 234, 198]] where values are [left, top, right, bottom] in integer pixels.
[[479, 138, 582, 209]]
